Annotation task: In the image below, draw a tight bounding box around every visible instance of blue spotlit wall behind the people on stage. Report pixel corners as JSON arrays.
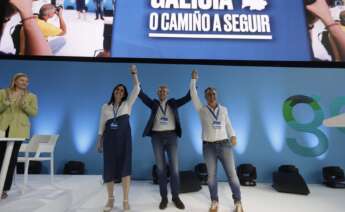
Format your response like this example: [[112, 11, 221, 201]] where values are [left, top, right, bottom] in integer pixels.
[[0, 60, 345, 183]]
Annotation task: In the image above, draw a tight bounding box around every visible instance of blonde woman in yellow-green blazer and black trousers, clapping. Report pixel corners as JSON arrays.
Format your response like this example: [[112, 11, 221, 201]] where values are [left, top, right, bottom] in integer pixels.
[[0, 73, 38, 199]]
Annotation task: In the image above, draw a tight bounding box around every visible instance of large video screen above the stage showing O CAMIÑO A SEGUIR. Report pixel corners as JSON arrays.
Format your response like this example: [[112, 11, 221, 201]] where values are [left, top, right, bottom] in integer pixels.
[[0, 0, 345, 62]]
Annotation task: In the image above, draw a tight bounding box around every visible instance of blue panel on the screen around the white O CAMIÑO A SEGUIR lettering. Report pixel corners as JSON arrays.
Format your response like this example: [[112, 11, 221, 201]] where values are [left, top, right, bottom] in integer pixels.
[[112, 0, 311, 61]]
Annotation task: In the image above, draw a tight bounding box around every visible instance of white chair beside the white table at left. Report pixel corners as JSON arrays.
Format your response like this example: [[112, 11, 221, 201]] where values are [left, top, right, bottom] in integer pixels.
[[18, 135, 59, 186]]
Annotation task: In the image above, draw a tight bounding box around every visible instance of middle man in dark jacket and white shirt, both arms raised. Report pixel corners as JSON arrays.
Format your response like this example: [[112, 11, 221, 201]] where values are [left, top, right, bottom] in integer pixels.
[[139, 85, 191, 209]]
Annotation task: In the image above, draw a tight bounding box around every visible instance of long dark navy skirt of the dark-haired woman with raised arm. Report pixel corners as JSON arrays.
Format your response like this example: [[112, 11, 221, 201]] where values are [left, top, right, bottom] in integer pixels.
[[103, 115, 132, 183]]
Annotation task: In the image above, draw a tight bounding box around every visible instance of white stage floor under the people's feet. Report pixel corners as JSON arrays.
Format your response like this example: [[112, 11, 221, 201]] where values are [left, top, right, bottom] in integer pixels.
[[0, 175, 345, 212]]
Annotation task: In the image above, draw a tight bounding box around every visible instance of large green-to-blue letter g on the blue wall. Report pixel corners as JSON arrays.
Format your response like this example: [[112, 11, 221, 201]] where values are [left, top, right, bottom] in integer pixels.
[[283, 95, 328, 157]]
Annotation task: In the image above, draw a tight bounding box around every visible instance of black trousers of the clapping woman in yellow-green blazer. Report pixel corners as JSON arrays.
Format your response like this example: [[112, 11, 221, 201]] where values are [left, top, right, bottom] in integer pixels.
[[0, 128, 22, 191]]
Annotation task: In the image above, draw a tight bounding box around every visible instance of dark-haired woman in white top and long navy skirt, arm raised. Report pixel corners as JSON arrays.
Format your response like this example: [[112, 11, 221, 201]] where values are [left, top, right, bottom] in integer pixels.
[[97, 65, 140, 211]]
